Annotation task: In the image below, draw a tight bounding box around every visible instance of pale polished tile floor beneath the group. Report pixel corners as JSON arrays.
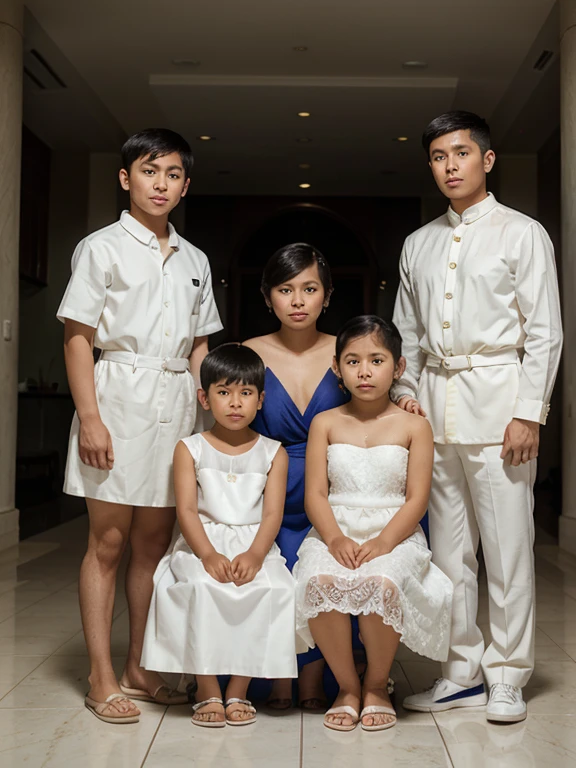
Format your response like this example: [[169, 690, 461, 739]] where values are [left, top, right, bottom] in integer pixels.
[[0, 518, 576, 768]]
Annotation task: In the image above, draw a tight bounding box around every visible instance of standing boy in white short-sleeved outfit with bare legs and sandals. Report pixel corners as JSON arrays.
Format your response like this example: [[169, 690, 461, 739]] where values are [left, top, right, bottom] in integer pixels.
[[58, 129, 222, 723]]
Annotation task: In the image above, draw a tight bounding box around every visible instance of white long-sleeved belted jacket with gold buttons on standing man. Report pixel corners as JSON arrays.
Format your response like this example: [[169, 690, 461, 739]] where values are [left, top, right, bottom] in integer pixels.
[[392, 194, 562, 444]]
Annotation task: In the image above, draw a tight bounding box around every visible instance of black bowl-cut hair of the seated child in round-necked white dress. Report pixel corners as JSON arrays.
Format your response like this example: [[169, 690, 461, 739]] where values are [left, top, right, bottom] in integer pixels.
[[200, 342, 266, 394]]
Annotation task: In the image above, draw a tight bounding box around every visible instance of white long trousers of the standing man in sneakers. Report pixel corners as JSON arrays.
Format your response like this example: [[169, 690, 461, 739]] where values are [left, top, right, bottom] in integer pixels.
[[429, 444, 536, 687]]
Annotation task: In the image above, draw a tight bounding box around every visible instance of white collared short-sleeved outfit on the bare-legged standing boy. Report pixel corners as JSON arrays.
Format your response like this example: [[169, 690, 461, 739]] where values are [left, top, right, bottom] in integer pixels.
[[57, 211, 222, 507]]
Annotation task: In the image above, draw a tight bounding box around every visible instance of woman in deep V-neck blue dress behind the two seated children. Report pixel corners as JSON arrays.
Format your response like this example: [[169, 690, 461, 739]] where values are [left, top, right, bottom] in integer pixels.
[[244, 243, 348, 710]]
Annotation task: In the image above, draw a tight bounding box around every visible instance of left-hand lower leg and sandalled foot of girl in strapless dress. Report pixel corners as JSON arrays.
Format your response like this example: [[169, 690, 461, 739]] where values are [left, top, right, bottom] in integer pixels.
[[308, 611, 361, 725]]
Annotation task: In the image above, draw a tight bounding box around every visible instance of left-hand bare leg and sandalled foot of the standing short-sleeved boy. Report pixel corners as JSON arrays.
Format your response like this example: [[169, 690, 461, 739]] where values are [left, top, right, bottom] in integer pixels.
[[79, 499, 139, 714]]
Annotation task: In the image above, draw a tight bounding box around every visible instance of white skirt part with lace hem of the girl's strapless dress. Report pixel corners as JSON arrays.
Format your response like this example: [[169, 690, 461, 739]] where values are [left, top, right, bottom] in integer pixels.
[[293, 506, 453, 661]]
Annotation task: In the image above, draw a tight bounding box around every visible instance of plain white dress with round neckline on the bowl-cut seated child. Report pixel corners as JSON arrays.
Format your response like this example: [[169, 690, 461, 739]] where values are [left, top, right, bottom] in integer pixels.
[[141, 434, 298, 678]]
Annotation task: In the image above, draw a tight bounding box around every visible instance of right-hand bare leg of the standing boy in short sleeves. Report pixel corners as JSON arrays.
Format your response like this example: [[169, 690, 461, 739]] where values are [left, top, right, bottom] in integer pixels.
[[122, 507, 176, 694]]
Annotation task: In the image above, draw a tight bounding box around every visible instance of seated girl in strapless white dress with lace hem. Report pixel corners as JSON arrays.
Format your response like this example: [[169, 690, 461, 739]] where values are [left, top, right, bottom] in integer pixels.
[[294, 315, 452, 730]]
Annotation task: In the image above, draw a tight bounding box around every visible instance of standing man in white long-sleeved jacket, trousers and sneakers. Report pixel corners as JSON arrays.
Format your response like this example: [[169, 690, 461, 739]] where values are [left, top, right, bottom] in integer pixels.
[[394, 112, 562, 722]]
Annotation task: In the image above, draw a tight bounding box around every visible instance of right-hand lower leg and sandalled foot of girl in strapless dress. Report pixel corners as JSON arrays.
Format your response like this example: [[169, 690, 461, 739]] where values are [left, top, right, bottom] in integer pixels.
[[358, 613, 400, 725]]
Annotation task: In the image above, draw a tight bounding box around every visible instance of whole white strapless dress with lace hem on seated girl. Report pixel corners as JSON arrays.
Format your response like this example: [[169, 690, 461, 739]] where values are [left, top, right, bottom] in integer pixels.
[[293, 443, 453, 661]]
